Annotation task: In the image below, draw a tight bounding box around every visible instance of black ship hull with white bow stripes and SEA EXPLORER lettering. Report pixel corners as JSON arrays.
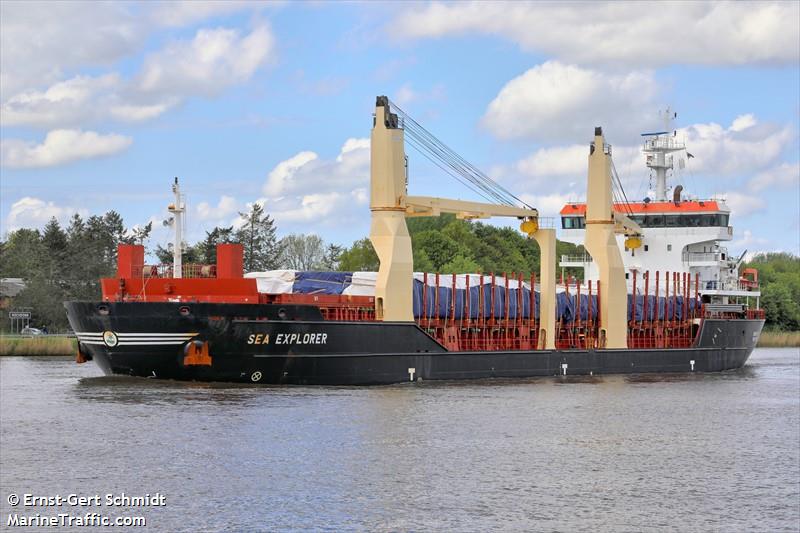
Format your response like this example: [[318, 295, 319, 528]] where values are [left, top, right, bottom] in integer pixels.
[[65, 302, 764, 385]]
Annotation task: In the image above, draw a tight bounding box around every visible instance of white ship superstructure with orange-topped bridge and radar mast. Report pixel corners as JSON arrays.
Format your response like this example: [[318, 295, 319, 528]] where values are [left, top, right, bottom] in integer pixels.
[[559, 110, 760, 303]]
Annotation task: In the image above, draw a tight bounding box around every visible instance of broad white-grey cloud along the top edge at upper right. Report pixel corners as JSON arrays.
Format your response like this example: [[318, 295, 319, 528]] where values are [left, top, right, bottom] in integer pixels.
[[390, 2, 800, 67]]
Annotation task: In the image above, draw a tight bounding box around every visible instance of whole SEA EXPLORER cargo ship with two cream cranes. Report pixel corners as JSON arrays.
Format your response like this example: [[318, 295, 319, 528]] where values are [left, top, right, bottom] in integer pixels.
[[64, 96, 764, 385]]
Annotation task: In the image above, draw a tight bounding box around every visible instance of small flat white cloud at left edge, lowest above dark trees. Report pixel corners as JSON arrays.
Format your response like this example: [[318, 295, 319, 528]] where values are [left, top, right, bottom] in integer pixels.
[[0, 130, 133, 168]]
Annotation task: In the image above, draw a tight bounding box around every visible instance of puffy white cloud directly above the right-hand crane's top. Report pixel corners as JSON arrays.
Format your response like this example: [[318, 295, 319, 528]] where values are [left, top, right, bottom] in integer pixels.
[[483, 61, 657, 142]]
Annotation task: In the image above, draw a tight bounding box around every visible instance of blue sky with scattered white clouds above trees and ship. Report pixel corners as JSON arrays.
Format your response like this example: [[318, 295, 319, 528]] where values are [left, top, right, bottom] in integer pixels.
[[0, 1, 800, 254]]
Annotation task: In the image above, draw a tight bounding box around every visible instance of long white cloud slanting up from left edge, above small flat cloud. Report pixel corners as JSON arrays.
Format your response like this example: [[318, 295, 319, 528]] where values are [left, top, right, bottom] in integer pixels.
[[0, 25, 274, 128]]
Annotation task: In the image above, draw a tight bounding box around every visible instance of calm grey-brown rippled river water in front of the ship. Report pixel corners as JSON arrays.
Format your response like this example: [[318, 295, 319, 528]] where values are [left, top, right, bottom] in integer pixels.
[[0, 349, 800, 532]]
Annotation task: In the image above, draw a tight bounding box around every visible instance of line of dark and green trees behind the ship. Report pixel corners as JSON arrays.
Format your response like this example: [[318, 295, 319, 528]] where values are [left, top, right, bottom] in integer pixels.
[[0, 204, 800, 330]]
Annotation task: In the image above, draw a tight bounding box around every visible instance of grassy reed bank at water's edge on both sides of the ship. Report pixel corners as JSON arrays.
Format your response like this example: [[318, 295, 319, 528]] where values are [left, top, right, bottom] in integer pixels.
[[0, 331, 800, 357]]
